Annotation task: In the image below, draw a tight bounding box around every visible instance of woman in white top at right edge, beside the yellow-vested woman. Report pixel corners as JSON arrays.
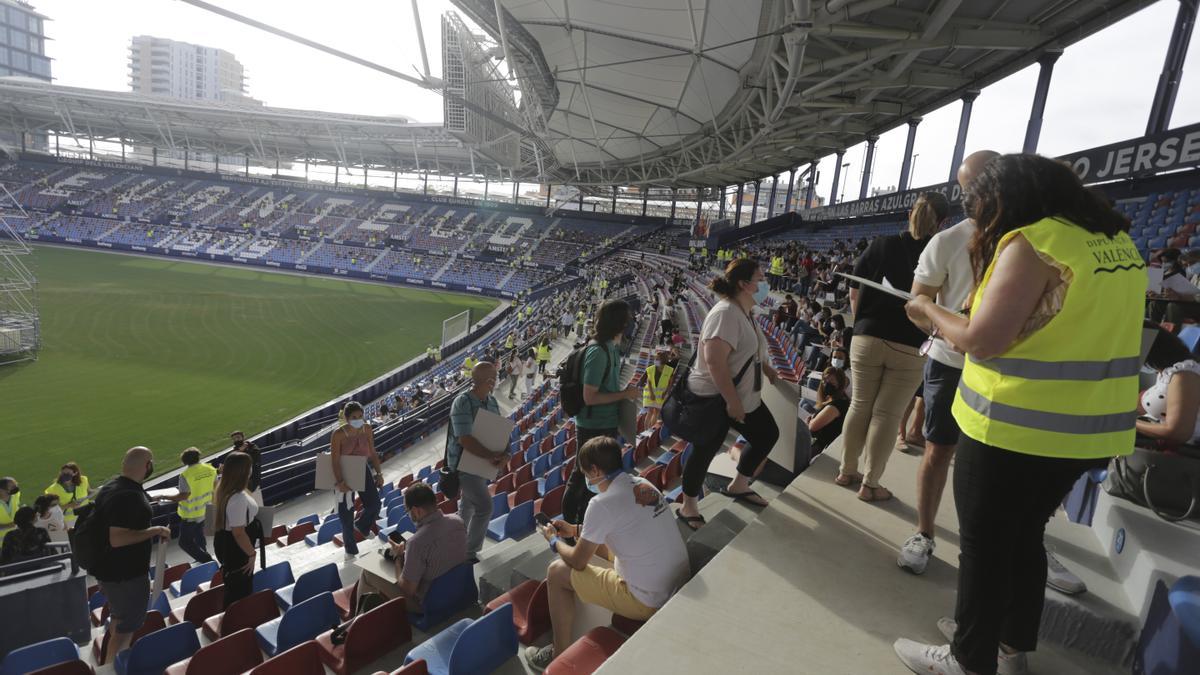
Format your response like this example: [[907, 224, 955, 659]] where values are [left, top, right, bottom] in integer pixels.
[[1138, 322, 1200, 444]]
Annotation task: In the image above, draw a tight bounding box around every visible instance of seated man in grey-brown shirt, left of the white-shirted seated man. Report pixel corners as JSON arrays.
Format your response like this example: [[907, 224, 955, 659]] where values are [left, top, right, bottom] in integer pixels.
[[359, 483, 467, 611]]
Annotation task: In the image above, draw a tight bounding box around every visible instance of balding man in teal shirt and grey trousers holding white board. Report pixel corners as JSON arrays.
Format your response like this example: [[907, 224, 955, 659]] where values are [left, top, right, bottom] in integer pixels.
[[446, 362, 509, 562]]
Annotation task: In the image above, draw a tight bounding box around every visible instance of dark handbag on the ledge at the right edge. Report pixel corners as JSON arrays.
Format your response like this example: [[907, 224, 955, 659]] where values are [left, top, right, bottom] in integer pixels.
[[1104, 447, 1200, 522]]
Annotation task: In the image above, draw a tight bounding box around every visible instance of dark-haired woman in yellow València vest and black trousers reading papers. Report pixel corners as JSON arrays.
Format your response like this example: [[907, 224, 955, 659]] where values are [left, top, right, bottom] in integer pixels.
[[895, 155, 1146, 675]]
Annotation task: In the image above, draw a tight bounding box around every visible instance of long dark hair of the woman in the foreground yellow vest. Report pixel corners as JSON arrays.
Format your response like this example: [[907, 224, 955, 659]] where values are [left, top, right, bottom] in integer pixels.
[[962, 154, 1129, 281]]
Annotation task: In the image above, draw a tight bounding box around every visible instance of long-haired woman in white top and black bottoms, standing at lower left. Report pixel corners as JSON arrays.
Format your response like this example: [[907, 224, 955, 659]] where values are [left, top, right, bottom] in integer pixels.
[[212, 452, 262, 609]]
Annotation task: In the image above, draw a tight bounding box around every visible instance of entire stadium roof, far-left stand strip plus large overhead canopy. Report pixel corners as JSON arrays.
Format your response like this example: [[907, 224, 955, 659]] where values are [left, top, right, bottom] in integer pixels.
[[0, 0, 1153, 190]]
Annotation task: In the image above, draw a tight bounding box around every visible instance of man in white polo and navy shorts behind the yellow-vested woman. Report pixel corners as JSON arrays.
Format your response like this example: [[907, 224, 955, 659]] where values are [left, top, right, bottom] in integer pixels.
[[896, 150, 1000, 574]]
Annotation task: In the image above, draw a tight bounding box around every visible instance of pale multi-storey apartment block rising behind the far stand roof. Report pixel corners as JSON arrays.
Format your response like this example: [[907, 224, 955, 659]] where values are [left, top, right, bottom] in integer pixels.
[[130, 35, 262, 106]]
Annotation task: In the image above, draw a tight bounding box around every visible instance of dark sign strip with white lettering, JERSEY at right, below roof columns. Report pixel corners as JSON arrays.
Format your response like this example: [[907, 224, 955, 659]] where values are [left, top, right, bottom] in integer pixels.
[[800, 124, 1200, 221]]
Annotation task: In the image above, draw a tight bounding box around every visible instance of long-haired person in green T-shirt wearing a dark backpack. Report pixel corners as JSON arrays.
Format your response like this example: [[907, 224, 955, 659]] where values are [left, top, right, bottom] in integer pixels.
[[563, 300, 641, 525]]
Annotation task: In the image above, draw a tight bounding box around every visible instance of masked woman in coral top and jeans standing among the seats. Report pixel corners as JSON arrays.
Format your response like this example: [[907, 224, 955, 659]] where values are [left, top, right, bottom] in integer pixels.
[[329, 401, 383, 558]]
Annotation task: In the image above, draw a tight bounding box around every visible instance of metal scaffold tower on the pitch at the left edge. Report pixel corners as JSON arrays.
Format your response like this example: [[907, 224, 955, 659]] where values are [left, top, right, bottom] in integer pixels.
[[0, 184, 42, 364]]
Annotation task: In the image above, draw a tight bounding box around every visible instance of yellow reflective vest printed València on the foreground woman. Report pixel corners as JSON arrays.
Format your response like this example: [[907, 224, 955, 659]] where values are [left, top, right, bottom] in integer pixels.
[[953, 219, 1146, 459]]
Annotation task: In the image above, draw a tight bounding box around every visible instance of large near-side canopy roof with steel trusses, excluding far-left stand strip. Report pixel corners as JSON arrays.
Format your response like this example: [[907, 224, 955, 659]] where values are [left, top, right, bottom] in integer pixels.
[[454, 0, 1152, 186]]
